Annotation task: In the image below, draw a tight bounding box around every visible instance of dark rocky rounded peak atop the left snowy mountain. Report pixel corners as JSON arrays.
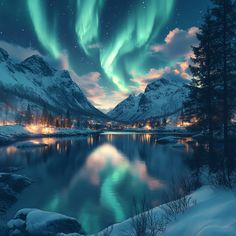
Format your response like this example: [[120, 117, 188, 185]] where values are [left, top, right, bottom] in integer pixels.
[[21, 55, 55, 76]]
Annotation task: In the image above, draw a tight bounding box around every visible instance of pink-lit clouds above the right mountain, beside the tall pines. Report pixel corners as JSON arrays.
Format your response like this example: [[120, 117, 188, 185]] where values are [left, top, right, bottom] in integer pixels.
[[128, 27, 199, 92]]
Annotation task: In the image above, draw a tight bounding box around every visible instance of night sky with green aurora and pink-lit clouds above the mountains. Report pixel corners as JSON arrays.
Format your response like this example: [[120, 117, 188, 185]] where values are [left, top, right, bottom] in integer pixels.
[[0, 0, 210, 111]]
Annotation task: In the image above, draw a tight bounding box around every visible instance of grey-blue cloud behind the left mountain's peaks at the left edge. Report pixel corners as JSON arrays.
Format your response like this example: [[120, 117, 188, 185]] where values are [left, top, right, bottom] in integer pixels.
[[0, 41, 41, 61]]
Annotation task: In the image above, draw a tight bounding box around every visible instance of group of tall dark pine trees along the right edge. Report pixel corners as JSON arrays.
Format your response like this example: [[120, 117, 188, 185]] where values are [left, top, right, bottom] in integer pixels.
[[184, 0, 236, 156]]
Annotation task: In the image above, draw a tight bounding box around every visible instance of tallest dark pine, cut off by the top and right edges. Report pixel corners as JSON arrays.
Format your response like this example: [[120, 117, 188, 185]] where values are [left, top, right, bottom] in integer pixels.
[[212, 0, 236, 156]]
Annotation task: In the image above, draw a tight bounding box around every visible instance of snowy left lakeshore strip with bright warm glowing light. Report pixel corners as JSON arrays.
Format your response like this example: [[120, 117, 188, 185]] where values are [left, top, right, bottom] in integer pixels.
[[0, 125, 97, 144]]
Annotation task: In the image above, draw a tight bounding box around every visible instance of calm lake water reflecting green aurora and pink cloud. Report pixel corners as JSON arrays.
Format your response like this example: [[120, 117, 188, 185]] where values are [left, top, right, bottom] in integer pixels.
[[0, 133, 195, 233]]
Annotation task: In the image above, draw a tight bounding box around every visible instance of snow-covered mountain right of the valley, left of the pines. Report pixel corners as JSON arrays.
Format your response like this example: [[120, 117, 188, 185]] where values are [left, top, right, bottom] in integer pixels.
[[108, 78, 188, 122]]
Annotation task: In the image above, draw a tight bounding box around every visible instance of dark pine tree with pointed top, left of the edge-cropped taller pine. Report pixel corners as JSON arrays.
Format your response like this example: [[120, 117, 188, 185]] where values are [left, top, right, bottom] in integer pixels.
[[184, 11, 217, 136]]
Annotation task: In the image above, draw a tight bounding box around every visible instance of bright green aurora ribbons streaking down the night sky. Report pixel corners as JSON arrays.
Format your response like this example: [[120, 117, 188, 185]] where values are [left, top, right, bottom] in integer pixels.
[[27, 0, 175, 92]]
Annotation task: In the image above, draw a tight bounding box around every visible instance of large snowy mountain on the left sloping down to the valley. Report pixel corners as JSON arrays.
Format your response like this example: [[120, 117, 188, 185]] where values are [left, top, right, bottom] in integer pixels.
[[0, 48, 105, 117]]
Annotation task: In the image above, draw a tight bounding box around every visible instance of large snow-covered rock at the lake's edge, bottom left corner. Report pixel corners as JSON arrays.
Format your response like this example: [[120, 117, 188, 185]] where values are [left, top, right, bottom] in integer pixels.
[[7, 208, 82, 236]]
